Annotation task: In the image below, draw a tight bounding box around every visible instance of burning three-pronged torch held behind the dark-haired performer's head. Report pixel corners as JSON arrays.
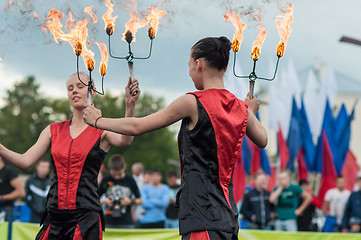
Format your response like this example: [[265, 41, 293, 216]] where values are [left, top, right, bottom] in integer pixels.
[[224, 3, 293, 98]]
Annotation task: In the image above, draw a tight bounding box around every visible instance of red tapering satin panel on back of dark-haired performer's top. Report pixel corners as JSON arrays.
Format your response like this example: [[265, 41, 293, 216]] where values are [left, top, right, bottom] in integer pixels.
[[188, 89, 248, 207]]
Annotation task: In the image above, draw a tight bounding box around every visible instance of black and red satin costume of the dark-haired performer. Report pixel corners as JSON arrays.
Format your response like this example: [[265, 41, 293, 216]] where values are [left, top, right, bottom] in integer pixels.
[[177, 89, 248, 240]]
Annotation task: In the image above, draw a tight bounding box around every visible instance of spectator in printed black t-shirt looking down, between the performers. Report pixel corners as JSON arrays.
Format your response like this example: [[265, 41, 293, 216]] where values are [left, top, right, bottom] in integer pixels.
[[99, 155, 142, 228]]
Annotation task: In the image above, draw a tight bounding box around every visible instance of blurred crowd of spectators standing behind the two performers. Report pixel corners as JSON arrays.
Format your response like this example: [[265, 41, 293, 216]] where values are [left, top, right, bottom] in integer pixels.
[[0, 155, 361, 236]]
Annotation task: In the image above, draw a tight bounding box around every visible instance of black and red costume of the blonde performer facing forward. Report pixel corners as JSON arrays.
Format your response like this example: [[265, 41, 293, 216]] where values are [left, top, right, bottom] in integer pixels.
[[36, 120, 106, 240]]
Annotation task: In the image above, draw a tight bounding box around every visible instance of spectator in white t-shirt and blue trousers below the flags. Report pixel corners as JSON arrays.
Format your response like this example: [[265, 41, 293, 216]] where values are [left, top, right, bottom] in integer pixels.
[[322, 176, 351, 232]]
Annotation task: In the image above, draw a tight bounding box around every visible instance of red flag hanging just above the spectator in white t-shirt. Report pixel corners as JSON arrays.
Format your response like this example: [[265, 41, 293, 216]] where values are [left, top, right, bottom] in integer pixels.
[[318, 130, 337, 202]]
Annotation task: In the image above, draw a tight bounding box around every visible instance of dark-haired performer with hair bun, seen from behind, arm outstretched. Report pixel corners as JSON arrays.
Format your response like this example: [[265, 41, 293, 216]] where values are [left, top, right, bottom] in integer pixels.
[[83, 37, 268, 240]]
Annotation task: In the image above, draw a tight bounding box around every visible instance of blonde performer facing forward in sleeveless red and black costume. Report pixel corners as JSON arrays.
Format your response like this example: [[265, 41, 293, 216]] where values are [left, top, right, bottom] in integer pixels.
[[0, 73, 140, 240]]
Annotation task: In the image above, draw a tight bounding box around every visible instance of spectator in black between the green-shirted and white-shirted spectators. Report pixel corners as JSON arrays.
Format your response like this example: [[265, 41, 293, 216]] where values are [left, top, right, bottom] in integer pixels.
[[297, 180, 322, 232]]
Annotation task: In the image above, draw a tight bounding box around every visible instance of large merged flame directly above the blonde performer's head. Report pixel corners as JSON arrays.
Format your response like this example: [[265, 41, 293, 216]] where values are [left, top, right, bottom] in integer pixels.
[[44, 8, 95, 71]]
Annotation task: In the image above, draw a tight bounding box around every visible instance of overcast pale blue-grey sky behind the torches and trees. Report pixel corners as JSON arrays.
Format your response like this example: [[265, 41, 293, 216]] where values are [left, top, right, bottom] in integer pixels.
[[0, 0, 361, 102]]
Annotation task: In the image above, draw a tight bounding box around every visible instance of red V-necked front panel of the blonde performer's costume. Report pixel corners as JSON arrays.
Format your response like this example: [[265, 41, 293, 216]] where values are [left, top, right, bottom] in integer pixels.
[[50, 120, 103, 209]]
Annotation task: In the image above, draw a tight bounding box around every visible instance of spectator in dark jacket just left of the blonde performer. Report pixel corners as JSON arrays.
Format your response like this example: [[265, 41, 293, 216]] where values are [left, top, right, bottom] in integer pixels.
[[25, 159, 51, 223]]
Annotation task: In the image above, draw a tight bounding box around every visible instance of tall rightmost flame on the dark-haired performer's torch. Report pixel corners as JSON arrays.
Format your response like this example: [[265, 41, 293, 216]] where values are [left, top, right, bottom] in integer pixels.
[[275, 2, 293, 57]]
